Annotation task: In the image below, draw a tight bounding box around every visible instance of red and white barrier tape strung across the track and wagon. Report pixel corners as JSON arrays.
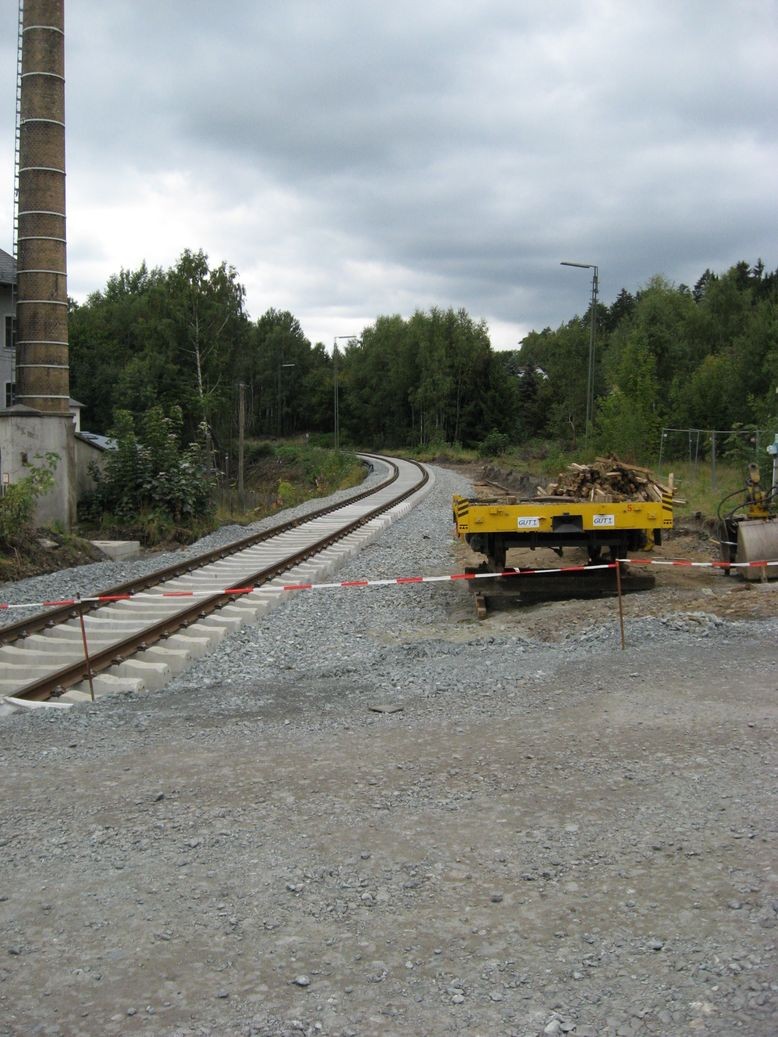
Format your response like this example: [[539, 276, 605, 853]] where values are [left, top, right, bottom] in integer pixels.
[[0, 558, 778, 611]]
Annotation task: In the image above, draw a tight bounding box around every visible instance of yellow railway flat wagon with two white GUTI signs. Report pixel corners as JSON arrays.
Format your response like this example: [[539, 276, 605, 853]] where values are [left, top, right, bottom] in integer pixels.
[[453, 494, 672, 571]]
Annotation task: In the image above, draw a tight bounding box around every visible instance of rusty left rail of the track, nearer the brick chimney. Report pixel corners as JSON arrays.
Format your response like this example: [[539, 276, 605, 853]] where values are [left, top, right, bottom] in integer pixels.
[[0, 454, 399, 647]]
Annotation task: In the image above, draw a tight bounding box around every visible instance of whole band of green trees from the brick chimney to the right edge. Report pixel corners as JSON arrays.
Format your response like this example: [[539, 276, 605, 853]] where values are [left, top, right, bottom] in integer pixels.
[[70, 251, 778, 457]]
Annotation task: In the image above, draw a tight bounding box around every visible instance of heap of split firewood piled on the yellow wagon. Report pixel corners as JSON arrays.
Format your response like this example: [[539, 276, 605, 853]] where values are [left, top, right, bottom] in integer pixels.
[[536, 454, 673, 504]]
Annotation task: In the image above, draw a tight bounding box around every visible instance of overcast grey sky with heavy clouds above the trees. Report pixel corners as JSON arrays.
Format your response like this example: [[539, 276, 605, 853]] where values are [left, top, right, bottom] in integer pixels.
[[0, 0, 778, 348]]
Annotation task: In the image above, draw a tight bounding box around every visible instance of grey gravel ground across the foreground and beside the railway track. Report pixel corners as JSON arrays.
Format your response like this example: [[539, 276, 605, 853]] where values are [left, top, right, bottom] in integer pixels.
[[0, 469, 778, 1037]]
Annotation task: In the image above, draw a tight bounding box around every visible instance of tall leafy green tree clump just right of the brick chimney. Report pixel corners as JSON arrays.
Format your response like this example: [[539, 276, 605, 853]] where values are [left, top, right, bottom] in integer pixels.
[[70, 251, 249, 447]]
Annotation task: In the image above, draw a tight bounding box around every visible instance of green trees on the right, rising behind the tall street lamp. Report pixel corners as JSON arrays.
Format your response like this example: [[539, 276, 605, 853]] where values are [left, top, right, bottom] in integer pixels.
[[513, 261, 778, 456]]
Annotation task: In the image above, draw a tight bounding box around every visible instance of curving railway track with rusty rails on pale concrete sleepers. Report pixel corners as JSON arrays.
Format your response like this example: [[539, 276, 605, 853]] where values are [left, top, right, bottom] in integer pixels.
[[0, 454, 429, 705]]
